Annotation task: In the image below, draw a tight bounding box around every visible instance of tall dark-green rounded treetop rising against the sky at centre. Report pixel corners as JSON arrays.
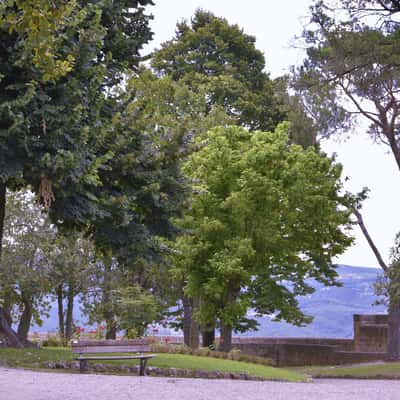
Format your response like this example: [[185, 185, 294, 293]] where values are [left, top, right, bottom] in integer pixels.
[[151, 10, 284, 131]]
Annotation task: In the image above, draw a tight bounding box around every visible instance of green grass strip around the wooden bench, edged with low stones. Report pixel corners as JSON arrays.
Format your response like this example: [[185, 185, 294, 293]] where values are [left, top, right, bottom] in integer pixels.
[[0, 348, 306, 382]]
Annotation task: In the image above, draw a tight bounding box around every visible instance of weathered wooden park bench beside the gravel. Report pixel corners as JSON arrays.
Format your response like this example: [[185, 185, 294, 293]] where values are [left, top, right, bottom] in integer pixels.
[[72, 339, 156, 376]]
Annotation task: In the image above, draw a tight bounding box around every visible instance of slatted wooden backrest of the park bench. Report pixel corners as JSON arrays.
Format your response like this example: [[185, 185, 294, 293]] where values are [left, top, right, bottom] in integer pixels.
[[72, 339, 151, 354]]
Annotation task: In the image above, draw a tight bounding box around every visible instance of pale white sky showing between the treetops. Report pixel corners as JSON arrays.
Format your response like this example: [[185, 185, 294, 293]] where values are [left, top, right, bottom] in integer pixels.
[[145, 0, 400, 267]]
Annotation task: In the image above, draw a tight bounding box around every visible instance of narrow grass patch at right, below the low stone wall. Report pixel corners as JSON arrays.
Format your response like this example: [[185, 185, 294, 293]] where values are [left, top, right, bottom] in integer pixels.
[[292, 362, 400, 379]]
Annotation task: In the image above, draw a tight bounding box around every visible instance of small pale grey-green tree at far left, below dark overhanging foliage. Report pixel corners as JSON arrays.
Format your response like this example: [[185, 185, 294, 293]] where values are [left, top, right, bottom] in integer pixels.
[[0, 191, 56, 343]]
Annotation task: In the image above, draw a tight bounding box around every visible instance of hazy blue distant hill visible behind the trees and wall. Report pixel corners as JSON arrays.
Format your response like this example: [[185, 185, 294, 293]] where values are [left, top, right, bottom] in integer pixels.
[[32, 265, 386, 338]]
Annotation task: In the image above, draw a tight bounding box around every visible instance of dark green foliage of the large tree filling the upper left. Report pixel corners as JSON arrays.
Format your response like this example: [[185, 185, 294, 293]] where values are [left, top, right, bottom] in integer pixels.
[[0, 0, 185, 346]]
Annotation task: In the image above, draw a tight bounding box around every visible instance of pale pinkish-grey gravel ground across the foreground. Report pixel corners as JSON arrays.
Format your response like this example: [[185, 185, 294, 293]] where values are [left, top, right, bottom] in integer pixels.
[[0, 368, 400, 400]]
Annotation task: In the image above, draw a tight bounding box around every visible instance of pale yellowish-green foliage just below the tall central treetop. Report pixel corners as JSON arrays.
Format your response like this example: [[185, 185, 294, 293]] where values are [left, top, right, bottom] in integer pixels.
[[127, 68, 233, 143]]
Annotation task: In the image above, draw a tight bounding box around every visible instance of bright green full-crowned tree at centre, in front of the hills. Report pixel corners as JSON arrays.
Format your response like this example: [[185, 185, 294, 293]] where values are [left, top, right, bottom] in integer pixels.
[[174, 124, 354, 351]]
